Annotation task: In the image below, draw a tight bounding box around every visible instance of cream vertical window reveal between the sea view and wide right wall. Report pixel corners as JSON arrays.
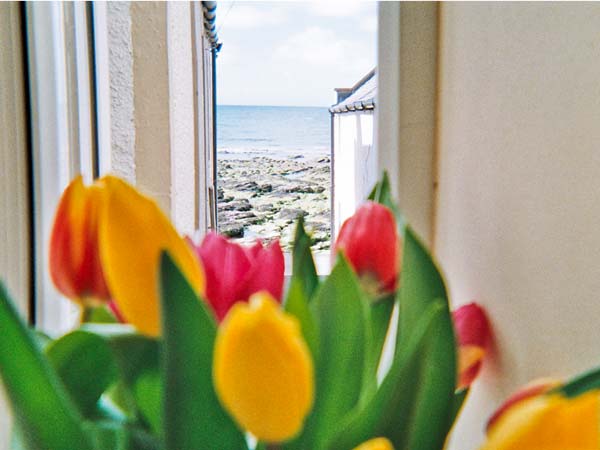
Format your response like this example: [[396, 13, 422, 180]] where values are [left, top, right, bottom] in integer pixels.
[[375, 2, 438, 244]]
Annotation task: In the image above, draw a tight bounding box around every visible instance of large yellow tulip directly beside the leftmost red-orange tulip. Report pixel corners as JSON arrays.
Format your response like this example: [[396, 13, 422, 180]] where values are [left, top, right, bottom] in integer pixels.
[[99, 176, 204, 336]]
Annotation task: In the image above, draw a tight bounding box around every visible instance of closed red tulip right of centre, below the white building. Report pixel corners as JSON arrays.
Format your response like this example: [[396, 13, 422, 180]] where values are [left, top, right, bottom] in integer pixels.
[[335, 201, 401, 296]]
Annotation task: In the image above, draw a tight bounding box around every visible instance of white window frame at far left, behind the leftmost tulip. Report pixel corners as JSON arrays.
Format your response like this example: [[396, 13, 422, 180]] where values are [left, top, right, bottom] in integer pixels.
[[26, 2, 93, 335]]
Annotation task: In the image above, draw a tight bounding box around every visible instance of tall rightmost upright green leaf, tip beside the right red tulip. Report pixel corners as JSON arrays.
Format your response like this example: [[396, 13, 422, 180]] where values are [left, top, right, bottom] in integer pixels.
[[396, 227, 456, 450]]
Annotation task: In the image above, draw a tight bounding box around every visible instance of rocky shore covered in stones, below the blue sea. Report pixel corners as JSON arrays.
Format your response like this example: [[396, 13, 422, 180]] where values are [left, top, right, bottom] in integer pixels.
[[217, 156, 331, 250]]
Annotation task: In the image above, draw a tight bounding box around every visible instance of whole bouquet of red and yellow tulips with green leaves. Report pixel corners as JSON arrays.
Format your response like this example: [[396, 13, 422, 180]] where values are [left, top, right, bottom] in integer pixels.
[[0, 176, 600, 450]]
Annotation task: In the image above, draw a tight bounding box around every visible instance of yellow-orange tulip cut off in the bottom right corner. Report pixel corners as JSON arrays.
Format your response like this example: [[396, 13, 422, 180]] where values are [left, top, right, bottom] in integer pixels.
[[481, 390, 600, 450]]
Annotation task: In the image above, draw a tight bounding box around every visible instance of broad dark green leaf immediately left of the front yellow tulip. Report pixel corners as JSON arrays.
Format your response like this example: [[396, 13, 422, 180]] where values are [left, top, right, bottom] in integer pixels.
[[160, 253, 248, 450]]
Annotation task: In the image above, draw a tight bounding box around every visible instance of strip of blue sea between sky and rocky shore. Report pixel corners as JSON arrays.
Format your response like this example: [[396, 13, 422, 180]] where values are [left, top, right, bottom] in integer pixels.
[[217, 105, 331, 159]]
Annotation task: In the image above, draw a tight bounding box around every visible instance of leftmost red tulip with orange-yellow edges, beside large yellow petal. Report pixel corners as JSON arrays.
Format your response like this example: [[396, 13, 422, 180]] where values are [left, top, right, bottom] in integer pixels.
[[49, 176, 110, 306]]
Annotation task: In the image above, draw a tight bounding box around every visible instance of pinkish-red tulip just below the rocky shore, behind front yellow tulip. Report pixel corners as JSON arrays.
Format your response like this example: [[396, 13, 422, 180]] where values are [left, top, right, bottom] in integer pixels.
[[196, 232, 284, 321]]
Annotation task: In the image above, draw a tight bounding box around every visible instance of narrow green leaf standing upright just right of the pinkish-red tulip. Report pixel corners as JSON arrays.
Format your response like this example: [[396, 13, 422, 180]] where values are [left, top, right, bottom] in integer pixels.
[[284, 218, 319, 359]]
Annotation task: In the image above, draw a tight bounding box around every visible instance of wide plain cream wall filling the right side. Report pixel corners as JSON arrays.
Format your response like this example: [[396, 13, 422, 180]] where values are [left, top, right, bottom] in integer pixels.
[[435, 3, 600, 450]]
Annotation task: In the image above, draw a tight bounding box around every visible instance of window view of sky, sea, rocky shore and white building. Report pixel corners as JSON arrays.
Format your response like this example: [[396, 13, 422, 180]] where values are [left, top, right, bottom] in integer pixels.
[[217, 2, 377, 273]]
